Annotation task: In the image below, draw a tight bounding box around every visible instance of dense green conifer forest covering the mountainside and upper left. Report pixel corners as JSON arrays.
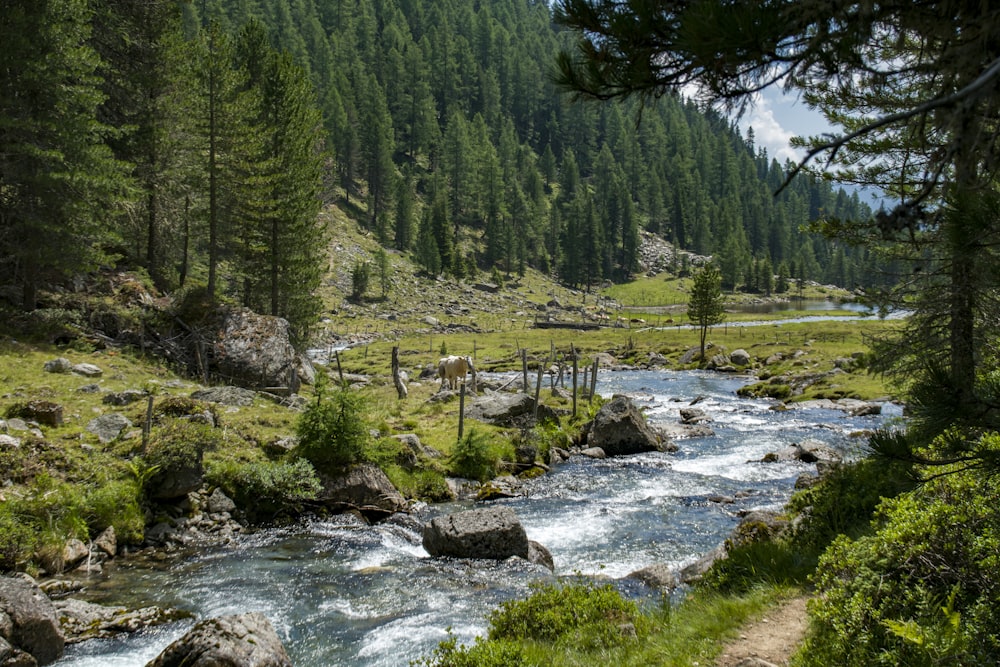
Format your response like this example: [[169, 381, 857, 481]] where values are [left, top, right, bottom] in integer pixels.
[[0, 0, 885, 342]]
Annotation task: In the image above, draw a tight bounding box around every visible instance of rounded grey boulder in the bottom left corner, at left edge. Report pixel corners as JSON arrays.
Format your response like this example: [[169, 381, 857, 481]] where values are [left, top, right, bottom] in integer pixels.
[[0, 577, 66, 665]]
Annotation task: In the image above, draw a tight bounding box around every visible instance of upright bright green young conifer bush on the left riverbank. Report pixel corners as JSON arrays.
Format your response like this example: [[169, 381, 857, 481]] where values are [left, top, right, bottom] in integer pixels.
[[295, 376, 371, 472]]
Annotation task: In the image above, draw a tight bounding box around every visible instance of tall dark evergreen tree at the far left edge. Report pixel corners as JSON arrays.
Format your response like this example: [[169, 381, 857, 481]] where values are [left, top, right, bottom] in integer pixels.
[[0, 0, 125, 310]]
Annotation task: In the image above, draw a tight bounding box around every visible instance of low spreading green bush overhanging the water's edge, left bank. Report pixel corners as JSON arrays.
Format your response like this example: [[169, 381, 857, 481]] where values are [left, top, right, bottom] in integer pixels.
[[206, 459, 322, 521]]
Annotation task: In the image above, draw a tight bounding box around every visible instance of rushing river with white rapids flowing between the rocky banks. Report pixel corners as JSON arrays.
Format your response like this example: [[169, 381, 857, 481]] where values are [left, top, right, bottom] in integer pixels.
[[56, 371, 899, 667]]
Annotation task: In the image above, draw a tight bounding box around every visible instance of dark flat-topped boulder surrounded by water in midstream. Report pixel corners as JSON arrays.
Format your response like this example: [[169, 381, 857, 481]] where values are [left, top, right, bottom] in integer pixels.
[[423, 507, 530, 560]]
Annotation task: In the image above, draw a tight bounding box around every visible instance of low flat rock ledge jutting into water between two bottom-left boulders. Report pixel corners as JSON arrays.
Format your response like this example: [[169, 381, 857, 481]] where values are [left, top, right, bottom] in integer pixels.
[[52, 598, 188, 644]]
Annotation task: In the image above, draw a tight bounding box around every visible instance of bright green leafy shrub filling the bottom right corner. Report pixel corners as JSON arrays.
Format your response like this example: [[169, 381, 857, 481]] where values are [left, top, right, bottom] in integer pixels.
[[798, 444, 1000, 667]]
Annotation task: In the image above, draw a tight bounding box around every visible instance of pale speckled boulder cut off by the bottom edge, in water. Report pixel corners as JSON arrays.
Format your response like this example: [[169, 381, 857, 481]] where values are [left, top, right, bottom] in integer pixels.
[[146, 612, 292, 667]]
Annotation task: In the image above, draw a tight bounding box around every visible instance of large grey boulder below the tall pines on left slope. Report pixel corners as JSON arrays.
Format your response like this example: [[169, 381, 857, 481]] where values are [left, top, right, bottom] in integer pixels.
[[214, 308, 300, 393]]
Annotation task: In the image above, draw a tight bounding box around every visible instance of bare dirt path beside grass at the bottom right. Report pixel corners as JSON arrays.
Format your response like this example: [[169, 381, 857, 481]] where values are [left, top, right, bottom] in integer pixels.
[[715, 596, 809, 667]]
